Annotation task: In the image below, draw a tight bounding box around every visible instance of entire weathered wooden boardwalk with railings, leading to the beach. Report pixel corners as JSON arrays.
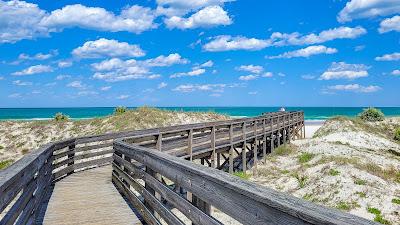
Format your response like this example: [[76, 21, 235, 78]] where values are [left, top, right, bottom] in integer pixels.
[[0, 112, 375, 225]]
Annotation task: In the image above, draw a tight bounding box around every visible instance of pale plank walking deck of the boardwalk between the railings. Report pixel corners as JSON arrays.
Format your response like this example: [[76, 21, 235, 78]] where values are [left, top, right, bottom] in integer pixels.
[[43, 166, 142, 225]]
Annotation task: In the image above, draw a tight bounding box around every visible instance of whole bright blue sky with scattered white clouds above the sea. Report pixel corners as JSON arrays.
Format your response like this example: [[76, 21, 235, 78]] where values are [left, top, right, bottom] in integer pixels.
[[0, 0, 400, 107]]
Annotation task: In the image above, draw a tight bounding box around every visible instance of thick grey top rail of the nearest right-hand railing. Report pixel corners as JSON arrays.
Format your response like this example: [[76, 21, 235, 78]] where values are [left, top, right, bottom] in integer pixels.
[[114, 140, 376, 225]]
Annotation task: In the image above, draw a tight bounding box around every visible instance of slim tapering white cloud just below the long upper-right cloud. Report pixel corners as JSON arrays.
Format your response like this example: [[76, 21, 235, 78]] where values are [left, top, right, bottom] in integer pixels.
[[268, 45, 338, 59]]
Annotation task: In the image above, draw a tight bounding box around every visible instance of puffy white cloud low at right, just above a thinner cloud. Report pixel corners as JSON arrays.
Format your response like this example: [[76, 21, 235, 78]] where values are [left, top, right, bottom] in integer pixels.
[[320, 62, 369, 80]]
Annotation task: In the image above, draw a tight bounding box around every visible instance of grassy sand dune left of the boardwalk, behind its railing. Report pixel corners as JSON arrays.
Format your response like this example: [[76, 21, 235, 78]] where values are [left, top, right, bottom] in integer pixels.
[[0, 107, 228, 166]]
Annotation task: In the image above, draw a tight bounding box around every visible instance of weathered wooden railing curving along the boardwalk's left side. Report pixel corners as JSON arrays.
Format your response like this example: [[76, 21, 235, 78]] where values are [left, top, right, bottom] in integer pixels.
[[0, 110, 294, 224]]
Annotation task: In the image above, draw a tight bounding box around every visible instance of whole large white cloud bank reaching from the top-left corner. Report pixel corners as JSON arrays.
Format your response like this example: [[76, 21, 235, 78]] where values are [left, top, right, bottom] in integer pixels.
[[0, 0, 157, 43]]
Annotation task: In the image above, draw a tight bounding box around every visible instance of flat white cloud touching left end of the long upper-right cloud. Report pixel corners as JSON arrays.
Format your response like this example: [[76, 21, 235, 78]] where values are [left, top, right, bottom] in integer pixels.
[[203, 35, 271, 52]]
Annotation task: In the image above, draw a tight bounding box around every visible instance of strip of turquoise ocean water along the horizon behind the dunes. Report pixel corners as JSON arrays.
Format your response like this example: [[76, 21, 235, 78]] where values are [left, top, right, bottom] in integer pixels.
[[0, 107, 400, 120]]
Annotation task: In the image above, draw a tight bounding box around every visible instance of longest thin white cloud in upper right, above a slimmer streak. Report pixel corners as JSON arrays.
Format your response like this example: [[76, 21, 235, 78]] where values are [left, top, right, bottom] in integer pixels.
[[270, 26, 367, 46]]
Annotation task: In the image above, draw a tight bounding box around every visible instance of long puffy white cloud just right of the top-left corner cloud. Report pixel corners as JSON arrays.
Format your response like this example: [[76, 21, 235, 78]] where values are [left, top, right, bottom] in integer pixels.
[[40, 4, 156, 33]]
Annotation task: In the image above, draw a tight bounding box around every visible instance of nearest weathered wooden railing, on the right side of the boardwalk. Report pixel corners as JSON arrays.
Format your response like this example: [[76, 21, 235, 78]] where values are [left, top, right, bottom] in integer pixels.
[[113, 140, 377, 225]]
